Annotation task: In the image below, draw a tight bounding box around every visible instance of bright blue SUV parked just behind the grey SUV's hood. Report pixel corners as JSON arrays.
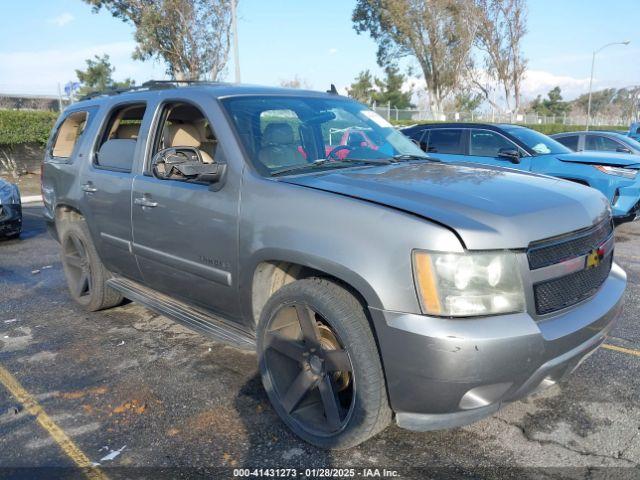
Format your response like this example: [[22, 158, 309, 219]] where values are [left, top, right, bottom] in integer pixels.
[[402, 123, 640, 224]]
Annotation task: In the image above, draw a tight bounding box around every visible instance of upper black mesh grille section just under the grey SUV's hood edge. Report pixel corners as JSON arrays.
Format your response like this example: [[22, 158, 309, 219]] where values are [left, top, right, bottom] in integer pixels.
[[527, 220, 613, 270]]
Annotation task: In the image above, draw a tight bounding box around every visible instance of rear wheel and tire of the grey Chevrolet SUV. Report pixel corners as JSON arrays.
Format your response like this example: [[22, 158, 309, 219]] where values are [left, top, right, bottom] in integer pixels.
[[59, 218, 123, 312]]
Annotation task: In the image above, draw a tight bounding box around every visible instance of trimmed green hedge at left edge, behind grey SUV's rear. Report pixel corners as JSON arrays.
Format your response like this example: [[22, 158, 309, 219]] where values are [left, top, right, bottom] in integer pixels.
[[0, 110, 58, 147]]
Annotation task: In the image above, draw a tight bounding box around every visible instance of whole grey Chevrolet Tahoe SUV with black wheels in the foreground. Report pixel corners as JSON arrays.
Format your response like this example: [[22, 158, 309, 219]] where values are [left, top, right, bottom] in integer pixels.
[[42, 83, 626, 448]]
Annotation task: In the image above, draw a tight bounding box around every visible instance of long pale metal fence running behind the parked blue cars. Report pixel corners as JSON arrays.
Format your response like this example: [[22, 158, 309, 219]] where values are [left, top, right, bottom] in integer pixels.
[[373, 107, 632, 127]]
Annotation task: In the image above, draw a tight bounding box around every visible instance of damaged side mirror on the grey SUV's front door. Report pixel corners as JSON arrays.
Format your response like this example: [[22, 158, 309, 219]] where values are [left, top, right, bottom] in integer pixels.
[[151, 147, 226, 183]]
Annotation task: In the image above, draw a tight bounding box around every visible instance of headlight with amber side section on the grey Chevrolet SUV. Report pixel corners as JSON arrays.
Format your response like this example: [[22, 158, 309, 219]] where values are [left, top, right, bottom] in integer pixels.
[[413, 250, 525, 317]]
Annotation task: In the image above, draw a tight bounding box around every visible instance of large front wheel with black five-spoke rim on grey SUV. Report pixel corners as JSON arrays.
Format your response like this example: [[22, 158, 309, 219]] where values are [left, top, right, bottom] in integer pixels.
[[258, 278, 391, 449]]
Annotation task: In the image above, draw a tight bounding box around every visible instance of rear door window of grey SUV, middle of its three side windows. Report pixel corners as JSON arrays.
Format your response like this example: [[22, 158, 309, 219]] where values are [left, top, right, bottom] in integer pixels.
[[93, 103, 146, 172]]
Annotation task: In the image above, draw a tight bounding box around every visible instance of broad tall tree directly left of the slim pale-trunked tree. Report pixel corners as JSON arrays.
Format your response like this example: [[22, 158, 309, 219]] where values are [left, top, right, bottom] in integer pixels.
[[352, 0, 477, 113]]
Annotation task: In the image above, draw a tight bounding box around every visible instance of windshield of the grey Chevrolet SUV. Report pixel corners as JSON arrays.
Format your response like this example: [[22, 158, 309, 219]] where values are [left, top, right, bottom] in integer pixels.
[[222, 95, 428, 175]]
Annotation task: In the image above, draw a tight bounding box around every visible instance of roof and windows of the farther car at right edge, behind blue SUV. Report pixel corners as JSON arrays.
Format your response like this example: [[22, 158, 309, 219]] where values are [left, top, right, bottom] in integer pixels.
[[551, 130, 640, 155]]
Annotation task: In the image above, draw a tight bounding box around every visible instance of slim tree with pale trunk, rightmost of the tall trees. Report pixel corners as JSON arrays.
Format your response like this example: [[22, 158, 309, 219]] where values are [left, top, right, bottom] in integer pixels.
[[474, 0, 527, 112]]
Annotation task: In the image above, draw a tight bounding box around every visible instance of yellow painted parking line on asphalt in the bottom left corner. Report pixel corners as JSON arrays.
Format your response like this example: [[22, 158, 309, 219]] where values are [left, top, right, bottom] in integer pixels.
[[0, 365, 108, 480]]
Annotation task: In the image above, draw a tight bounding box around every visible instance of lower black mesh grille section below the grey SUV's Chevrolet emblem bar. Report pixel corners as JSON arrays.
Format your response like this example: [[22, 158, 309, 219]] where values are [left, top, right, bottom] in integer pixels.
[[533, 254, 613, 315]]
